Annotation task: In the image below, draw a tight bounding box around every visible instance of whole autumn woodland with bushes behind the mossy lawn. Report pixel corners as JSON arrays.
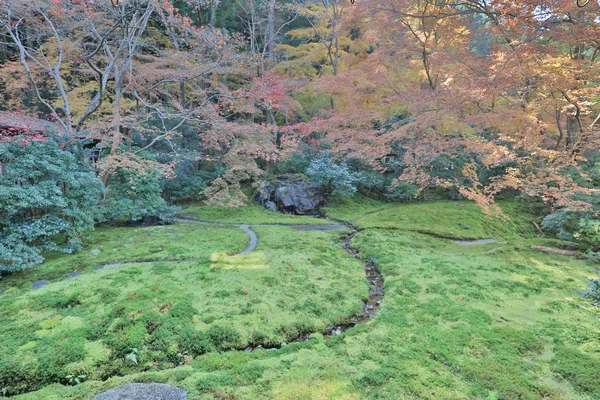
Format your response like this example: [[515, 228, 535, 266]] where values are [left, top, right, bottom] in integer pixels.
[[0, 0, 600, 271]]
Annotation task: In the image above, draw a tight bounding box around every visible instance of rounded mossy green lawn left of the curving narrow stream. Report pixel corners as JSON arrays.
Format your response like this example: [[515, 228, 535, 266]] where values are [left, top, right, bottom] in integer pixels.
[[0, 224, 368, 394]]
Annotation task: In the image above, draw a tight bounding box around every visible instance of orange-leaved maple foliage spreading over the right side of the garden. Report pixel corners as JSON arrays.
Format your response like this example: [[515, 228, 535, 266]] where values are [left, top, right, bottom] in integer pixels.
[[300, 0, 600, 212]]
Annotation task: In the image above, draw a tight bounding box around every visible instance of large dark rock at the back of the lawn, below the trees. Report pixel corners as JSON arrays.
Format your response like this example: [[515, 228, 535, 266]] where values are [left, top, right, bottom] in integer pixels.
[[255, 176, 325, 215]]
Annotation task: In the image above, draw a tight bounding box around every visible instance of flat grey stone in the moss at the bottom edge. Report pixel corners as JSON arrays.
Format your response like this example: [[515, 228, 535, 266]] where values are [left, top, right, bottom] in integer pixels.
[[94, 383, 187, 400]]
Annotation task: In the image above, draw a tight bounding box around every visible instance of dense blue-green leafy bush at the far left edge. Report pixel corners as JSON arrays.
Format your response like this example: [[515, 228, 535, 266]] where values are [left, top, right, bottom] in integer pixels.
[[0, 140, 102, 274]]
